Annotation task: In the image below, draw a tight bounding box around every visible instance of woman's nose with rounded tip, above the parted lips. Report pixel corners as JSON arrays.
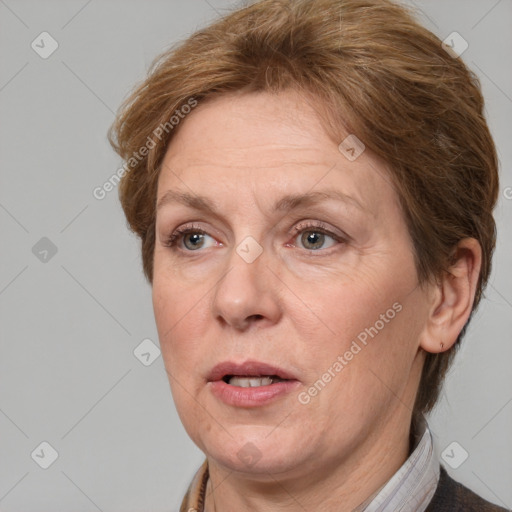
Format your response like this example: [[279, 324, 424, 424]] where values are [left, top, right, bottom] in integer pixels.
[[212, 244, 282, 331]]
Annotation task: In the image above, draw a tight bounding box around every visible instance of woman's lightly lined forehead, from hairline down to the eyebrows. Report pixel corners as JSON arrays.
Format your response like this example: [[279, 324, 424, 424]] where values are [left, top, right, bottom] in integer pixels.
[[157, 90, 395, 215]]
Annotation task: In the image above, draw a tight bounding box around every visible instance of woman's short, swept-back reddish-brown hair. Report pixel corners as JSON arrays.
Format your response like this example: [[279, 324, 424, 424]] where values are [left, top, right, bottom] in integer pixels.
[[109, 0, 499, 413]]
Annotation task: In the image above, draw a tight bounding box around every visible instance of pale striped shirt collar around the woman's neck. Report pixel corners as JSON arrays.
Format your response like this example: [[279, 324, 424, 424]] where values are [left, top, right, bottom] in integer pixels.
[[180, 417, 440, 512]]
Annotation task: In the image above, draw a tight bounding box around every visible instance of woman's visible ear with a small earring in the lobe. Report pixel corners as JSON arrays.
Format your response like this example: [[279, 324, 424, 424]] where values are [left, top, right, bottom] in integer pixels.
[[420, 238, 482, 353]]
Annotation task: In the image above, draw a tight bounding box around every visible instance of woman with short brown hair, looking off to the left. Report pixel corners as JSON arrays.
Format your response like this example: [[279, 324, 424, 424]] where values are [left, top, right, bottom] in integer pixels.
[[110, 0, 504, 512]]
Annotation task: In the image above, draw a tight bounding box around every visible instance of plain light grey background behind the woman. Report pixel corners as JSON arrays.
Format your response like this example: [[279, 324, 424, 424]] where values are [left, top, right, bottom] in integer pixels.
[[0, 0, 512, 512]]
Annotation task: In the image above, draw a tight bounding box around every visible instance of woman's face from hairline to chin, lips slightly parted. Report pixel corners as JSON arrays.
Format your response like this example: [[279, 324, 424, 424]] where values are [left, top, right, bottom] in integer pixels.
[[153, 91, 428, 475]]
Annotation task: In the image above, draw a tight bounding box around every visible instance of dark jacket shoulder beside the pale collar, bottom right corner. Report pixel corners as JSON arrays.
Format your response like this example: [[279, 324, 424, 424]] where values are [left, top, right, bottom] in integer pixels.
[[426, 466, 507, 512]]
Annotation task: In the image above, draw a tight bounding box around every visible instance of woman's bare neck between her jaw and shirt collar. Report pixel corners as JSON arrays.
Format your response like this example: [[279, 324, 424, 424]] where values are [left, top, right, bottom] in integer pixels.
[[205, 408, 411, 512]]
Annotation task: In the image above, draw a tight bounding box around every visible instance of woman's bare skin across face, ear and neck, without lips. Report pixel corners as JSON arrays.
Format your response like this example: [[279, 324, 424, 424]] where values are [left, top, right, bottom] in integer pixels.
[[153, 90, 480, 512]]
